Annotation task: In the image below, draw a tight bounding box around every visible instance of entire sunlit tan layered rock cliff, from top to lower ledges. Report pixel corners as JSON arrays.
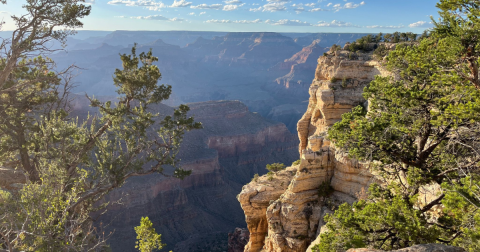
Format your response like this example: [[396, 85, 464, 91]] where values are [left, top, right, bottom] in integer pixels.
[[239, 46, 388, 252]]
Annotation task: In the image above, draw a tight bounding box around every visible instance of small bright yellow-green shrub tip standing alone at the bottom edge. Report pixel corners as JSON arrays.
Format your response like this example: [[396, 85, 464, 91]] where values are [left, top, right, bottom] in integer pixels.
[[135, 217, 165, 252]]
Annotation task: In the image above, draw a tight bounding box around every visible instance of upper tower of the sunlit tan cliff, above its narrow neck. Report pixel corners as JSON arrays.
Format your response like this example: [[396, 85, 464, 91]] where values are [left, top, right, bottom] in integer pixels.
[[297, 47, 389, 154]]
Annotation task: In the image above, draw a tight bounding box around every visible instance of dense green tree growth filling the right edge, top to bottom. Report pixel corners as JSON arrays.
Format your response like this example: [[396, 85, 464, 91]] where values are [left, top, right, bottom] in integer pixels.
[[316, 0, 480, 252]]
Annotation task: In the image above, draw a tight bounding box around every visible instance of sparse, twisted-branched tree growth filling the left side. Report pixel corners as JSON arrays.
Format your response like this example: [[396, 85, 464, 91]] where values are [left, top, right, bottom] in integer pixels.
[[0, 0, 201, 251]]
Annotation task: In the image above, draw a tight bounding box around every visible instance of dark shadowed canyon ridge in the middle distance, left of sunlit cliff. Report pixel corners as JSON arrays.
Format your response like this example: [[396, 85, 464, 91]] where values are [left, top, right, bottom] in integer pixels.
[[100, 101, 298, 252]]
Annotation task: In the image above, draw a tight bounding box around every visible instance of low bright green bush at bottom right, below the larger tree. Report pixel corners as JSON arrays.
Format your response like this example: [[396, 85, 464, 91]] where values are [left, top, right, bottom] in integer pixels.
[[313, 186, 440, 252]]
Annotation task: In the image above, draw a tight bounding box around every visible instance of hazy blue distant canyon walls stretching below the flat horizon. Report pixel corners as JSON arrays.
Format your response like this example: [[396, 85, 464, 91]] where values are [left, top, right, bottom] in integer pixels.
[[51, 31, 364, 134]]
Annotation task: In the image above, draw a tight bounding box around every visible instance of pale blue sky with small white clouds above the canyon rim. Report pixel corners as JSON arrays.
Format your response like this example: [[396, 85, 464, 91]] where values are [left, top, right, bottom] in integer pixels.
[[0, 0, 438, 33]]
